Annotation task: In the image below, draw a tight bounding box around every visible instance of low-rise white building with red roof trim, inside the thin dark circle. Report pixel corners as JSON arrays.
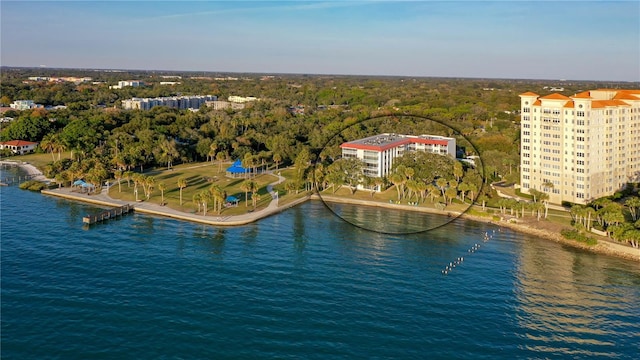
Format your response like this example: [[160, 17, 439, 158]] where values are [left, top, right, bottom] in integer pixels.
[[340, 134, 456, 181]]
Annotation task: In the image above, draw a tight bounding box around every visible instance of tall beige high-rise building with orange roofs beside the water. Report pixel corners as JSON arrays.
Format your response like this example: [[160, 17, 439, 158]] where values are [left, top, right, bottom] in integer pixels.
[[520, 89, 640, 204]]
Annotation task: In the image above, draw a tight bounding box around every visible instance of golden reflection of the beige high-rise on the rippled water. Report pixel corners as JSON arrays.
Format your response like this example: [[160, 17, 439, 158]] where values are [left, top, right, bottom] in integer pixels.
[[514, 239, 640, 357]]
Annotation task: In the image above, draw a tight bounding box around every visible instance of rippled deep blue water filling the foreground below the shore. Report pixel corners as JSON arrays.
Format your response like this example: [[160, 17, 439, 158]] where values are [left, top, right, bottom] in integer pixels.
[[0, 167, 640, 359]]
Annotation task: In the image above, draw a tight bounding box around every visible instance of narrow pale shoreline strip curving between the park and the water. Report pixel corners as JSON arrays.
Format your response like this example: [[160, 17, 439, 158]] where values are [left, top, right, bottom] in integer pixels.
[[3, 162, 640, 262]]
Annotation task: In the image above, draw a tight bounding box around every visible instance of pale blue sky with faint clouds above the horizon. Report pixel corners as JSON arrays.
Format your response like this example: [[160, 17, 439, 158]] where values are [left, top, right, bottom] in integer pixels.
[[0, 0, 640, 81]]
